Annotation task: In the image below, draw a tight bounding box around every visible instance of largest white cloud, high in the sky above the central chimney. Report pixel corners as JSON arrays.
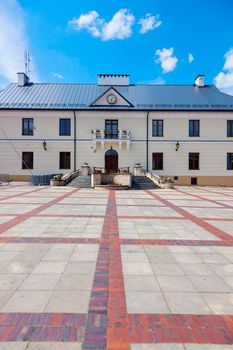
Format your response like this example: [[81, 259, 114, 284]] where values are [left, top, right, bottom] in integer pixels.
[[69, 9, 135, 41]]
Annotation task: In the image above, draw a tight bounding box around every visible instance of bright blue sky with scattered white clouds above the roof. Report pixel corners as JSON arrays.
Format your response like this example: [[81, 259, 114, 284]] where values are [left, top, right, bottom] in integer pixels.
[[0, 0, 233, 94]]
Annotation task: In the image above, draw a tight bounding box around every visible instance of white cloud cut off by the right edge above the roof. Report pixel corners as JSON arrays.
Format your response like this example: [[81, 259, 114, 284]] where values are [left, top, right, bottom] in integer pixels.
[[214, 48, 233, 95]]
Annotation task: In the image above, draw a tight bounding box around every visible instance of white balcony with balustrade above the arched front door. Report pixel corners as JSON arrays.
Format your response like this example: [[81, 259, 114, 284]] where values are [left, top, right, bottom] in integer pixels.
[[92, 129, 131, 149]]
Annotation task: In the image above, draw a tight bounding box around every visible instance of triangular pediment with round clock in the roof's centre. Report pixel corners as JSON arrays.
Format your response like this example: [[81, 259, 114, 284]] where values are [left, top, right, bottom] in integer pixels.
[[91, 87, 133, 107]]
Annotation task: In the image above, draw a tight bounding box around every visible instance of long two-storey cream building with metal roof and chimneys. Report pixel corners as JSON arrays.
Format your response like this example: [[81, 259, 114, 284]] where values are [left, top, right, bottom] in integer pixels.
[[0, 73, 233, 186]]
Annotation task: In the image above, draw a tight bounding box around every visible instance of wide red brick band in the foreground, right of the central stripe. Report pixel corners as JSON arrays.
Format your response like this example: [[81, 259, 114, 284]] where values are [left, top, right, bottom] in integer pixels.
[[128, 314, 233, 344]]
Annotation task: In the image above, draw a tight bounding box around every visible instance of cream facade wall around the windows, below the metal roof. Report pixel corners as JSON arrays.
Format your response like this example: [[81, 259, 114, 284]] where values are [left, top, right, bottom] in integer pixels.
[[0, 110, 233, 176]]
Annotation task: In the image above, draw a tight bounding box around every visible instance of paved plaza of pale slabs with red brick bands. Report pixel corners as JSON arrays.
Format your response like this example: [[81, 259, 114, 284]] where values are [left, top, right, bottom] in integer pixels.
[[0, 183, 233, 350]]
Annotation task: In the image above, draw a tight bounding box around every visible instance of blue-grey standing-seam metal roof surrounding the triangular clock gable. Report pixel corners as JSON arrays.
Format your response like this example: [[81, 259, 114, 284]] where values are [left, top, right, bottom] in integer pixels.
[[0, 84, 233, 110]]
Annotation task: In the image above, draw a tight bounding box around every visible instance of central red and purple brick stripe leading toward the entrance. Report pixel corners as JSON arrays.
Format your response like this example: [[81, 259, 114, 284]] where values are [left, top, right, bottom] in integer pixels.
[[82, 191, 130, 350]]
